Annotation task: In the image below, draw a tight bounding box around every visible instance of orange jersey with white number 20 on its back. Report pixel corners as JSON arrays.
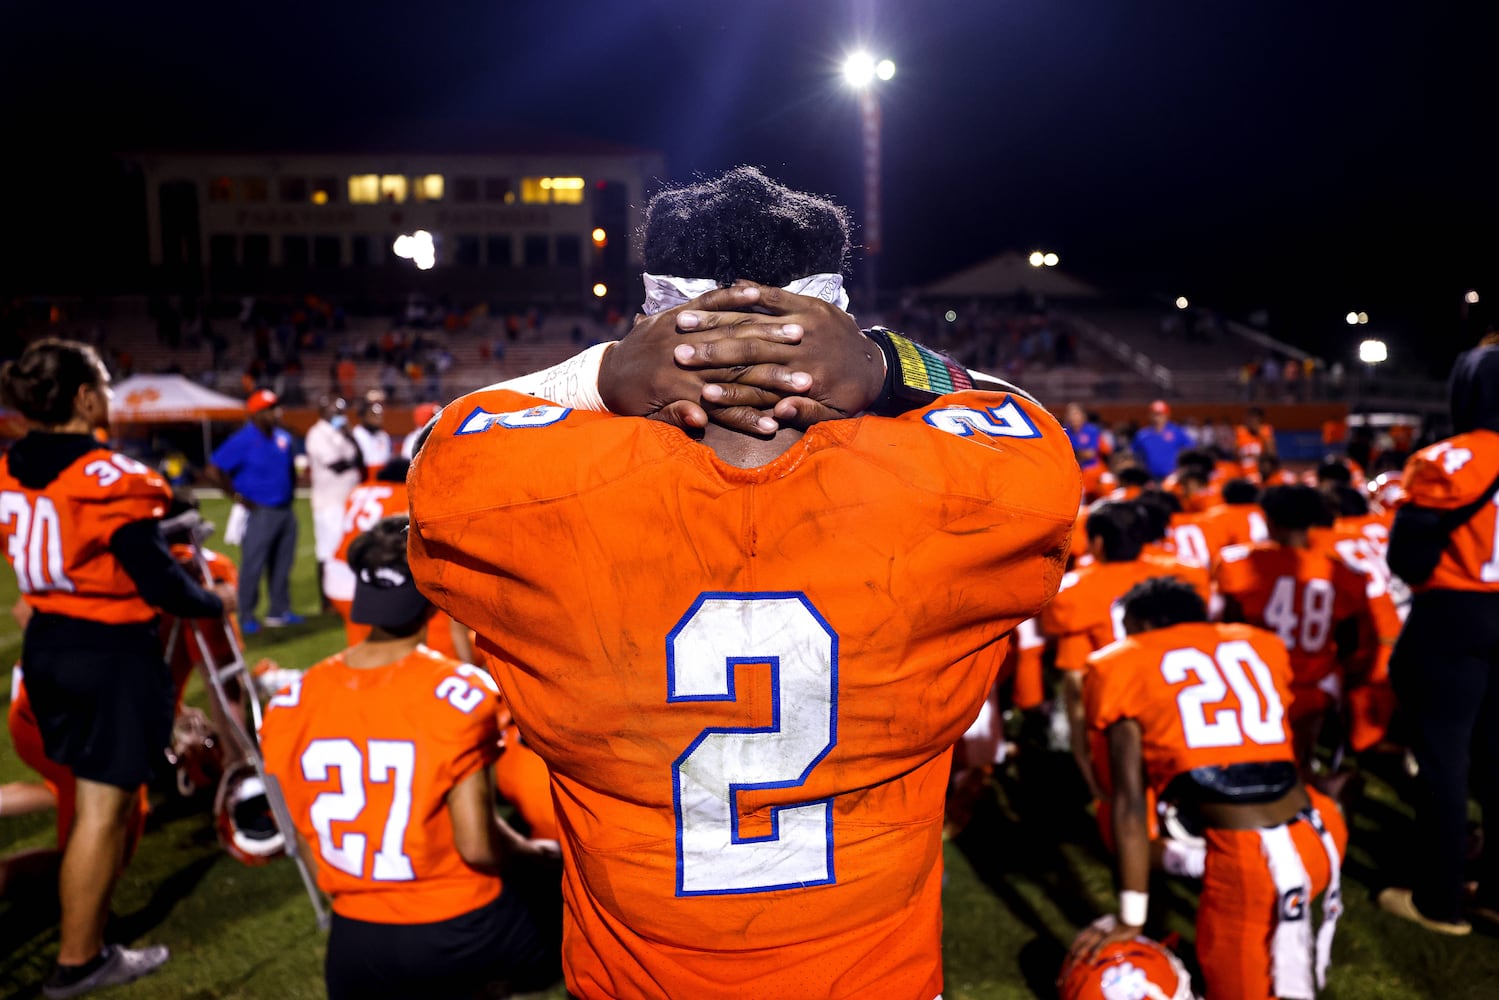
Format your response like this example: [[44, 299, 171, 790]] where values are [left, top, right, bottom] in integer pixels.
[[1082, 622, 1294, 795]]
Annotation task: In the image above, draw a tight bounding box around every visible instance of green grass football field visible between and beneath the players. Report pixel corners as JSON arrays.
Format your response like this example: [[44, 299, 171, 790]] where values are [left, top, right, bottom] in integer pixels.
[[0, 501, 1499, 1000]]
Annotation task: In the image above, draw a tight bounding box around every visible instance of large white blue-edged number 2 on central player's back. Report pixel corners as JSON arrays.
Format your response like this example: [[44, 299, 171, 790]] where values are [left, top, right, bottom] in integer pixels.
[[666, 594, 838, 897]]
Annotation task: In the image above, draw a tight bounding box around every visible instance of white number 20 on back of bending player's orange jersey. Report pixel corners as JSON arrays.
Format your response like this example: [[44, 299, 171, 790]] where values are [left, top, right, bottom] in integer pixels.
[[1160, 639, 1286, 750]]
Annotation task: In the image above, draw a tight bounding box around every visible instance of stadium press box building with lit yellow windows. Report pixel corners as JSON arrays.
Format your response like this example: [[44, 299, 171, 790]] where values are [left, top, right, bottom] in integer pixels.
[[130, 138, 666, 306]]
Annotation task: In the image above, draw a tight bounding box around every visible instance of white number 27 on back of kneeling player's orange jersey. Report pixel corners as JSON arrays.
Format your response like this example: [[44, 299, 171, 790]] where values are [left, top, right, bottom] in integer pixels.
[[301, 739, 417, 882]]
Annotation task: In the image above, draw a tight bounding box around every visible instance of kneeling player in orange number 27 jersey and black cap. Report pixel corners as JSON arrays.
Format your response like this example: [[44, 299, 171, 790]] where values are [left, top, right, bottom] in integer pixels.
[[261, 516, 559, 1000]]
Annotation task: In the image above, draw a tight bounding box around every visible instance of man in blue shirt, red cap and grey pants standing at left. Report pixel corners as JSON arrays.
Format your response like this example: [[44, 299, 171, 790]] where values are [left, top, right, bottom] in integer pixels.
[[207, 388, 303, 634]]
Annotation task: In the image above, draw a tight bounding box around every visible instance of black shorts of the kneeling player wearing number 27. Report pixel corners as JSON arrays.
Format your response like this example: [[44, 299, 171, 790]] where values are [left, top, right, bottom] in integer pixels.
[[324, 888, 561, 1000]]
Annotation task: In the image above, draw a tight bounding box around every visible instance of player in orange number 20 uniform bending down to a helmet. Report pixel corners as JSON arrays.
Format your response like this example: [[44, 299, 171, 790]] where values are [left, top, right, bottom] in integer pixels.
[[1079, 579, 1348, 1000]]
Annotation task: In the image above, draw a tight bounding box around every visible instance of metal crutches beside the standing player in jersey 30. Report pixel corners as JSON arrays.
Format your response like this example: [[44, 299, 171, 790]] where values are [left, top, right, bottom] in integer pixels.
[[163, 510, 330, 931]]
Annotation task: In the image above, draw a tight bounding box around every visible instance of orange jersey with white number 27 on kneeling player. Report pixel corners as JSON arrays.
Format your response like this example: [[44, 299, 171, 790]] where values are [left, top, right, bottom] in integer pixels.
[[261, 646, 499, 924]]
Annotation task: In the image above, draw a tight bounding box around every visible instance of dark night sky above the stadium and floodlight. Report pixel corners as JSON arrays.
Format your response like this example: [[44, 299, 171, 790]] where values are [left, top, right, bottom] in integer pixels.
[[0, 0, 1499, 366]]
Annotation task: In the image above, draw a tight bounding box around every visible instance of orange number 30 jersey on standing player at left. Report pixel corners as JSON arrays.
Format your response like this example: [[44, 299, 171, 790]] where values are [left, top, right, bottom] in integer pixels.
[[0, 448, 172, 625]]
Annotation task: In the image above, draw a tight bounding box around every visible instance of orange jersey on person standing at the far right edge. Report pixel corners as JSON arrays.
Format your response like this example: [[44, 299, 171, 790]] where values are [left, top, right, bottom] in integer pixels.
[[1402, 430, 1499, 592]]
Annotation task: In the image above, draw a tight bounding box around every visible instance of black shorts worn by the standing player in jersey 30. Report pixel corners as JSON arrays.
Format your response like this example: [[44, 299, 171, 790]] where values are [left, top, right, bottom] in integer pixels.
[[21, 613, 175, 789]]
